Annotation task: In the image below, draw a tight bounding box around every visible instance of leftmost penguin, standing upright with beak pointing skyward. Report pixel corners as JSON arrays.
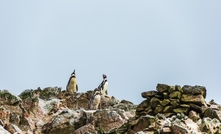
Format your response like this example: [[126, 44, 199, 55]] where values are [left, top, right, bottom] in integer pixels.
[[66, 70, 78, 93]]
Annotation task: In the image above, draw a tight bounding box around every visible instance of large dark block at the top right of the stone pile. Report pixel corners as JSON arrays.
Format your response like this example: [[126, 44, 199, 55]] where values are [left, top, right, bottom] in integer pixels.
[[182, 85, 206, 99]]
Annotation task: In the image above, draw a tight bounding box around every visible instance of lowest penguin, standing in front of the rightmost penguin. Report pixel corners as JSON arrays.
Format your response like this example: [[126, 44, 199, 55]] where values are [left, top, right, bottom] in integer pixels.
[[88, 90, 101, 110]]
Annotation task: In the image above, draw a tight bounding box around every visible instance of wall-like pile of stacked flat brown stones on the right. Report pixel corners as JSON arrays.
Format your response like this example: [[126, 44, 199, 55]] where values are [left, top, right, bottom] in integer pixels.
[[136, 84, 208, 118]]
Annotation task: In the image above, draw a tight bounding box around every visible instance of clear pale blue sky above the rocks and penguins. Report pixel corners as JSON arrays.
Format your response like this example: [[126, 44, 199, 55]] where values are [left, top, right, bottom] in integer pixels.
[[0, 0, 221, 104]]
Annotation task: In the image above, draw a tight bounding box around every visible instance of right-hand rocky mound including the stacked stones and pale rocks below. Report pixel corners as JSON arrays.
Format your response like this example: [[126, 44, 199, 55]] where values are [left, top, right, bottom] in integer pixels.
[[125, 84, 221, 134]]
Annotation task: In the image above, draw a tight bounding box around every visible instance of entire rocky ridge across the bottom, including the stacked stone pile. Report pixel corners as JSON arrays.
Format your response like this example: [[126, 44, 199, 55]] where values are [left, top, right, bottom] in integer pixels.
[[0, 84, 221, 134]]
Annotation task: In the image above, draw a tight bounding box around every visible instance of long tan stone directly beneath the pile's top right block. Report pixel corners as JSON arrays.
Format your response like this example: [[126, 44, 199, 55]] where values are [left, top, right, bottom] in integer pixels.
[[181, 94, 206, 106]]
